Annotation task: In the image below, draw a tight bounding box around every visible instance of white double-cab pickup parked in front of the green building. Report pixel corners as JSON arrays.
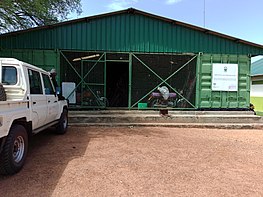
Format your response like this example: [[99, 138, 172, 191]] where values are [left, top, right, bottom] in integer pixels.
[[0, 58, 68, 175]]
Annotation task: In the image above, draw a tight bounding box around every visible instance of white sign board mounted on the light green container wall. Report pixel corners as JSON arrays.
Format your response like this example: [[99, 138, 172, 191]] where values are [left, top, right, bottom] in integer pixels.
[[212, 64, 238, 91]]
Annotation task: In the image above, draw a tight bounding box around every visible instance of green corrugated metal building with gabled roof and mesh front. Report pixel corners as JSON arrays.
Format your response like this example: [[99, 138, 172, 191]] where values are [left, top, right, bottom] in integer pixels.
[[0, 8, 263, 109]]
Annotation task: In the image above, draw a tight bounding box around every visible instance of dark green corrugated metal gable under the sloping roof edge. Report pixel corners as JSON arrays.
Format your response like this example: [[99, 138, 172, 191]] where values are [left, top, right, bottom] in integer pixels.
[[0, 8, 263, 56]]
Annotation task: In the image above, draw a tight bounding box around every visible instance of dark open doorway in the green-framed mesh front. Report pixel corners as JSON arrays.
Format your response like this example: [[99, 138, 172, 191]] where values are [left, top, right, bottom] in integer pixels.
[[106, 62, 129, 107]]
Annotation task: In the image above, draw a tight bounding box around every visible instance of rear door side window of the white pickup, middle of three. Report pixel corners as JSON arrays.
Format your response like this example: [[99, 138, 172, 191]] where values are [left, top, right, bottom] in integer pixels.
[[28, 69, 43, 94]]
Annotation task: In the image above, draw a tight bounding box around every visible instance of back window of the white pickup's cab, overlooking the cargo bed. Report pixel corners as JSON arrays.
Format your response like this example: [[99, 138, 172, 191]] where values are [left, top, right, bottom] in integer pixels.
[[2, 66, 17, 85]]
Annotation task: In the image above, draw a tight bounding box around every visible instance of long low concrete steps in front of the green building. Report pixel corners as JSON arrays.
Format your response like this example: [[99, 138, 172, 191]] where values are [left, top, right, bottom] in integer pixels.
[[69, 110, 263, 125]]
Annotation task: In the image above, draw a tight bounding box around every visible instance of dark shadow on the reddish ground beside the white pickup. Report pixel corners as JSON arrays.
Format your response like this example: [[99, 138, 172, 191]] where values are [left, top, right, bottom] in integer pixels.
[[0, 128, 90, 196]]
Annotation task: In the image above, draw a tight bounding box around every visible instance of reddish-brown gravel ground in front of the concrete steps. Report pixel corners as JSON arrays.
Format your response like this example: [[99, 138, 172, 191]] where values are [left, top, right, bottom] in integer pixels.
[[0, 127, 263, 197]]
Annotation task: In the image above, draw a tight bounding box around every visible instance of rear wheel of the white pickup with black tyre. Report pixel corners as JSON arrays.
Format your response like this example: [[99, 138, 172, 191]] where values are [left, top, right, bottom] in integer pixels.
[[0, 125, 28, 175]]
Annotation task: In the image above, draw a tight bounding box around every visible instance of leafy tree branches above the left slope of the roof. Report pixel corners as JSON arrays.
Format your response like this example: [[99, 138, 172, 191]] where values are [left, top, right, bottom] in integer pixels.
[[0, 0, 82, 33]]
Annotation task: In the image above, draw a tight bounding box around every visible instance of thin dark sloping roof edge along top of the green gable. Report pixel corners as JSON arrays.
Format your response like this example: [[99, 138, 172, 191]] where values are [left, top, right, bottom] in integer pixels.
[[0, 8, 263, 49]]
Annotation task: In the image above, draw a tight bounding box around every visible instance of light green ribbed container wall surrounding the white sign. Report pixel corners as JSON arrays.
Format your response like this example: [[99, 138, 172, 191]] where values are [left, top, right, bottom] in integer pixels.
[[196, 54, 250, 108]]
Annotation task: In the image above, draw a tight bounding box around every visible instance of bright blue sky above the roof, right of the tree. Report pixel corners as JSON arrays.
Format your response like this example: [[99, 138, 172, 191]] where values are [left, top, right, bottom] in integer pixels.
[[70, 0, 263, 61]]
